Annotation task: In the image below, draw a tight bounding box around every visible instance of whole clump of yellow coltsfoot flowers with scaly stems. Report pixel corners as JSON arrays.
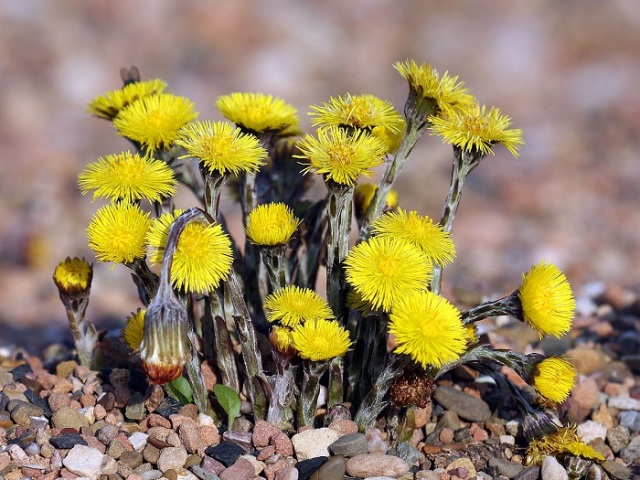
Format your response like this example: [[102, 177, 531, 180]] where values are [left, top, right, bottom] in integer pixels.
[[54, 60, 575, 442]]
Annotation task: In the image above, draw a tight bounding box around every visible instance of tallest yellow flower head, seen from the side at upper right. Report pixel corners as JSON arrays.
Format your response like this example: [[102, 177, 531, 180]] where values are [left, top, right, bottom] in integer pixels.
[[394, 60, 475, 115]]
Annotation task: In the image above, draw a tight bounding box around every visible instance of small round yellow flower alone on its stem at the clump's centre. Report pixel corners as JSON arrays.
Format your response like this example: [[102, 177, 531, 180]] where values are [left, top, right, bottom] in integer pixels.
[[246, 203, 300, 246]]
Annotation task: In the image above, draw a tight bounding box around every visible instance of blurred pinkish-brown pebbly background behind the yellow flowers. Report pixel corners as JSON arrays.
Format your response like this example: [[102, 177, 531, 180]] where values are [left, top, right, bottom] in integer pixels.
[[0, 0, 640, 352]]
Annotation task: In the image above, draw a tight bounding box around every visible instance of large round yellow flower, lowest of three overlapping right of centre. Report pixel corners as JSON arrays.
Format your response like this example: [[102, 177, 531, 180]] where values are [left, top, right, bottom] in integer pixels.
[[389, 291, 467, 368]]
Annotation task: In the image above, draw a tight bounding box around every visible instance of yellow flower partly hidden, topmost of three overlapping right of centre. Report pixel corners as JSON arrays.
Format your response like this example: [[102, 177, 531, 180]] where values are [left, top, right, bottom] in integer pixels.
[[371, 209, 456, 266]]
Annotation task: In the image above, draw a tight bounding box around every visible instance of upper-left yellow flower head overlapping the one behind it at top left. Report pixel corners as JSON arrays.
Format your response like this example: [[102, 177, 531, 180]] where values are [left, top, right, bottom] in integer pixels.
[[113, 93, 198, 151]]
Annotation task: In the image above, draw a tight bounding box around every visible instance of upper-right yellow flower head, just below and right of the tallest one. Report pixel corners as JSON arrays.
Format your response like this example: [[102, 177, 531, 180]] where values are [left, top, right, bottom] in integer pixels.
[[431, 104, 524, 157]]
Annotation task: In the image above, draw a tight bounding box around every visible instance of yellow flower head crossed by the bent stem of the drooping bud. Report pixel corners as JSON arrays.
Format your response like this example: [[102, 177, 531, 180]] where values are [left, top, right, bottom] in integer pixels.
[[147, 211, 233, 293]]
